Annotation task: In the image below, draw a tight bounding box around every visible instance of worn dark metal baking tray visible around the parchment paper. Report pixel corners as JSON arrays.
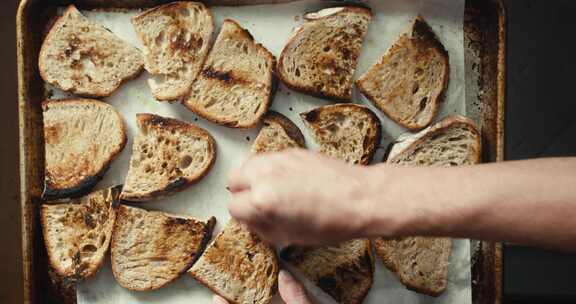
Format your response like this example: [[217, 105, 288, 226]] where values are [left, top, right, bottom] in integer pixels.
[[17, 0, 506, 303]]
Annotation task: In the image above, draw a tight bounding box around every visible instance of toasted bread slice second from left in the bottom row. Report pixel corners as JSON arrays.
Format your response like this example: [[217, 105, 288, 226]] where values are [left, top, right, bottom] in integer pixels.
[[111, 205, 216, 291]]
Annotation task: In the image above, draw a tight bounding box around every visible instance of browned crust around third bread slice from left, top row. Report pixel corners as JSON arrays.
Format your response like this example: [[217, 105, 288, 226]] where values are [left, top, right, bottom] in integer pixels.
[[182, 19, 278, 129]]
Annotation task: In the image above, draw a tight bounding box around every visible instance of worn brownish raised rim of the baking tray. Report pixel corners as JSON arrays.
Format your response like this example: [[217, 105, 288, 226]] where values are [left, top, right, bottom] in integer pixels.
[[16, 0, 506, 303]]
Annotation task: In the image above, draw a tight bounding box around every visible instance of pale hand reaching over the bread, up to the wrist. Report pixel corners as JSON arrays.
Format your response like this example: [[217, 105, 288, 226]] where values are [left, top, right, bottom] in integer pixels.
[[228, 150, 380, 244]]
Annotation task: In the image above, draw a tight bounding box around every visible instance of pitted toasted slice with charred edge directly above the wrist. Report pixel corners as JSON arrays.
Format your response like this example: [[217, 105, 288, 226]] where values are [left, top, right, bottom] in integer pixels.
[[300, 104, 382, 165]]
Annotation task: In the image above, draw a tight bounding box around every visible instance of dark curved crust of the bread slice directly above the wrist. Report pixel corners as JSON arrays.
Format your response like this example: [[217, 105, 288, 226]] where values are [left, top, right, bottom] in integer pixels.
[[300, 103, 382, 165]]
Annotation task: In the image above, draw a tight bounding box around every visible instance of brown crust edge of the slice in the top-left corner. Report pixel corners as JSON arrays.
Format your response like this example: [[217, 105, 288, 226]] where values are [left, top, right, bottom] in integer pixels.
[[38, 4, 144, 98]]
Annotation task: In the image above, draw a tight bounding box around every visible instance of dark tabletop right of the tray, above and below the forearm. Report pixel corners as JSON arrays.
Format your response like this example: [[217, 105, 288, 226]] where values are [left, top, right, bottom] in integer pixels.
[[504, 0, 576, 303]]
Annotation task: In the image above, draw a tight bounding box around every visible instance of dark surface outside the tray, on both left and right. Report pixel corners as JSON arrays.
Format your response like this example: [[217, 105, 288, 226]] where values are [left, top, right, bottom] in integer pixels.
[[0, 0, 576, 303]]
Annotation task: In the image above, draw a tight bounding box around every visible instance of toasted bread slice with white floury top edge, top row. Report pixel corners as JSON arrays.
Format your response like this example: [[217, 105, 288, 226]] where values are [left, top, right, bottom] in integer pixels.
[[277, 7, 372, 101]]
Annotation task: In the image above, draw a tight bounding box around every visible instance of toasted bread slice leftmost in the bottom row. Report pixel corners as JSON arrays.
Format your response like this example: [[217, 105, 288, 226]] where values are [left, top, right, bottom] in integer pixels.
[[40, 186, 121, 280]]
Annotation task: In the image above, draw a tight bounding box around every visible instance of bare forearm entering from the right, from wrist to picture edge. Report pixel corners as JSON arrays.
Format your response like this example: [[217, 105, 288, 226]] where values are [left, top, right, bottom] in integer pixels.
[[366, 158, 576, 249]]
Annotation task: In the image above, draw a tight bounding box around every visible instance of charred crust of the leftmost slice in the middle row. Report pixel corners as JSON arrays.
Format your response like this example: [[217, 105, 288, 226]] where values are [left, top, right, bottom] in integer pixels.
[[42, 99, 128, 200]]
